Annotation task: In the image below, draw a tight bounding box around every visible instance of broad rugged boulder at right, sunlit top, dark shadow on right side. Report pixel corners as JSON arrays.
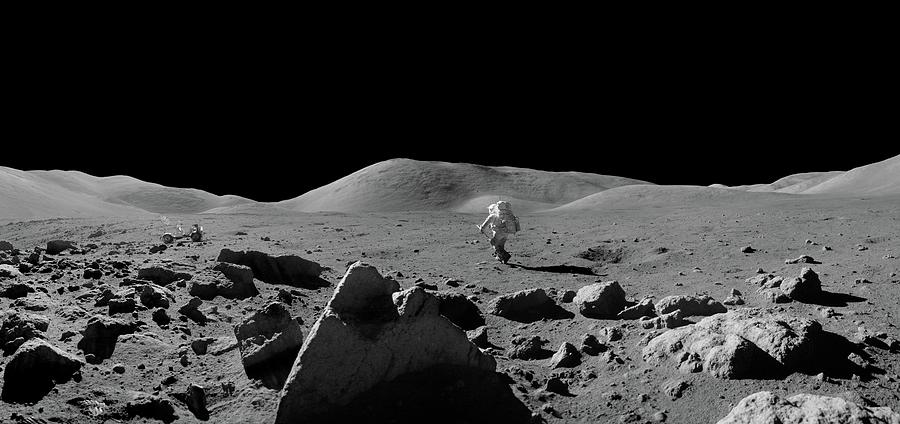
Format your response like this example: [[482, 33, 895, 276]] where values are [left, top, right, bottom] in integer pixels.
[[643, 309, 823, 379]]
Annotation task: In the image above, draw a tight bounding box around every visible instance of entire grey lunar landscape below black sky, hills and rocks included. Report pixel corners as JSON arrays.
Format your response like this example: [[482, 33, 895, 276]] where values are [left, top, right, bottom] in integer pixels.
[[0, 156, 900, 423]]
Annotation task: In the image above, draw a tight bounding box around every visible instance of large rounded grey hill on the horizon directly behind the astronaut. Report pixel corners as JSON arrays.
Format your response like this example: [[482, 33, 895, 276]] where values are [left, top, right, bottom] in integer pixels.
[[278, 159, 649, 213]]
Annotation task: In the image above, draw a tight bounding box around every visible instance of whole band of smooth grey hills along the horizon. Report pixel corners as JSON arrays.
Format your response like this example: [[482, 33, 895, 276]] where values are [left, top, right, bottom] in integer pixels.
[[0, 155, 900, 219]]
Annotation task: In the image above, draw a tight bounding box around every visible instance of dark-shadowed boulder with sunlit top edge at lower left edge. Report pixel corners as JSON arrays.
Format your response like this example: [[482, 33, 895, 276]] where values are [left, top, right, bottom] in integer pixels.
[[2, 339, 83, 403]]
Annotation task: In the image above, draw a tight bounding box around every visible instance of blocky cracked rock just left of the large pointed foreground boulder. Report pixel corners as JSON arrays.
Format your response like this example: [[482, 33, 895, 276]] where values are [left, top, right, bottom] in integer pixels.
[[234, 302, 303, 389]]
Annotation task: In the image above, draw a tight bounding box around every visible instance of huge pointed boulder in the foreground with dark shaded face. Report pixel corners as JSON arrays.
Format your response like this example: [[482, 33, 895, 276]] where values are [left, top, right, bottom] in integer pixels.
[[275, 262, 530, 423]]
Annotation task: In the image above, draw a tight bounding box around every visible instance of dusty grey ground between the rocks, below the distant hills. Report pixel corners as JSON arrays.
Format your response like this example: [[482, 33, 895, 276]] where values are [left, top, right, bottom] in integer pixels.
[[0, 194, 900, 423]]
